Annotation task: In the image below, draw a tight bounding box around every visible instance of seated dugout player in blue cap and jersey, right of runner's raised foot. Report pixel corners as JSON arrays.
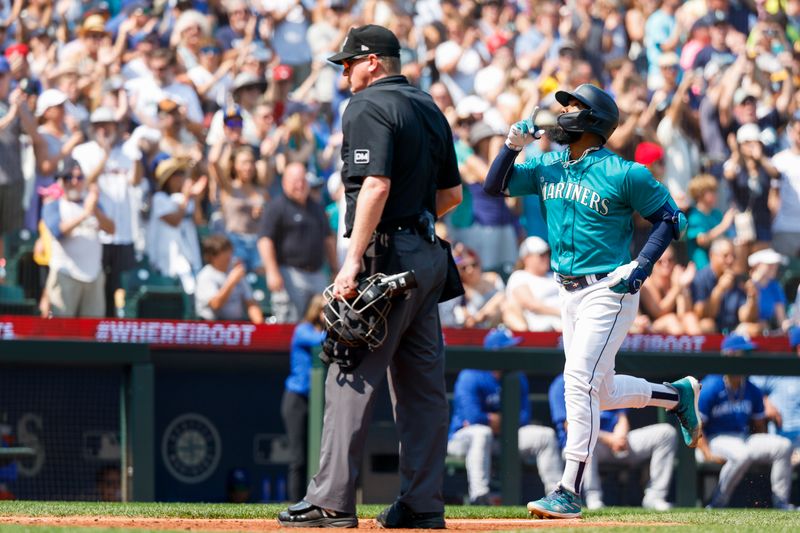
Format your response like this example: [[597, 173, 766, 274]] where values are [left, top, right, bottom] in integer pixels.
[[697, 333, 793, 510]]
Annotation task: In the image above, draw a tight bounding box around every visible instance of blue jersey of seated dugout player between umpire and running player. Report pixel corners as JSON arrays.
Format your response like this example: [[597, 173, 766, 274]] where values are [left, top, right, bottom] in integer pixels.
[[449, 368, 531, 437]]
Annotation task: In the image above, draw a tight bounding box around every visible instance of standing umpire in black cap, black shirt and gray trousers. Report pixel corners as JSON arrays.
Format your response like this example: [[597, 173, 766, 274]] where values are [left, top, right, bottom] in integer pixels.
[[278, 25, 461, 529]]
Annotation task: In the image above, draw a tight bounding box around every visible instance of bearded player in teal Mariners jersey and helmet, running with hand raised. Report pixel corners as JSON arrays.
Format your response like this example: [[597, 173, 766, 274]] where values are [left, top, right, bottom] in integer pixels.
[[484, 84, 702, 518]]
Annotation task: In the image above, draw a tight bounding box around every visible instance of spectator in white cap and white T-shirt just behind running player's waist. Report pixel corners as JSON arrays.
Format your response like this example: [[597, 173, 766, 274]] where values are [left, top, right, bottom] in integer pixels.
[[503, 236, 561, 331]]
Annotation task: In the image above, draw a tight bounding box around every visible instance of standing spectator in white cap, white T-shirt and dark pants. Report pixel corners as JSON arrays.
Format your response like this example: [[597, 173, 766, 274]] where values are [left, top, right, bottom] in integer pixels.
[[72, 107, 144, 316]]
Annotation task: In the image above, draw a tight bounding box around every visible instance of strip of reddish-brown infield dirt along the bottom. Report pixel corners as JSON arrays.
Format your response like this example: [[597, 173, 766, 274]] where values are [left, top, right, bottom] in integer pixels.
[[0, 516, 679, 532]]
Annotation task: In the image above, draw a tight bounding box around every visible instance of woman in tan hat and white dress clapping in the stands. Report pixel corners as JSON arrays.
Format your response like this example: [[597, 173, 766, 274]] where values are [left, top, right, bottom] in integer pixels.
[[147, 158, 208, 294]]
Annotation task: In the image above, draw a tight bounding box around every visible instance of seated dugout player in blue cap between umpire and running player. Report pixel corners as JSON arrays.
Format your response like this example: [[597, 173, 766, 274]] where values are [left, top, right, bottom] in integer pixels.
[[447, 326, 563, 505]]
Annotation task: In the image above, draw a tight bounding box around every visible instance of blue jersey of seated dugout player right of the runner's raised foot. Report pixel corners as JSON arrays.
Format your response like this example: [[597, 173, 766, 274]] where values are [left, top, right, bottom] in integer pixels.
[[698, 375, 764, 437]]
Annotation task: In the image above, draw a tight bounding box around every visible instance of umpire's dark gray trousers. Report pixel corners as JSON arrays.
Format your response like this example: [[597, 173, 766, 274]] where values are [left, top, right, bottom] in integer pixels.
[[305, 234, 448, 513]]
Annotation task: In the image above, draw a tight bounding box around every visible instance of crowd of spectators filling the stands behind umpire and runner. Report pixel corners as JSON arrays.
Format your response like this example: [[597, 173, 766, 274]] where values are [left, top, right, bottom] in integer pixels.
[[0, 0, 800, 334]]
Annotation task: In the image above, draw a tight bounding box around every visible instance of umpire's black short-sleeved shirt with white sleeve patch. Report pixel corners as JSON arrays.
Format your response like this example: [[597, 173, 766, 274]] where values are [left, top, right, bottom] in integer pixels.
[[342, 75, 461, 236]]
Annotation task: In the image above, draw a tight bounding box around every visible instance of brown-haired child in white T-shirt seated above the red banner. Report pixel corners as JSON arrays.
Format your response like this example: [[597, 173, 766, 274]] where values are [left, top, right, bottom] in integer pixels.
[[194, 235, 264, 324]]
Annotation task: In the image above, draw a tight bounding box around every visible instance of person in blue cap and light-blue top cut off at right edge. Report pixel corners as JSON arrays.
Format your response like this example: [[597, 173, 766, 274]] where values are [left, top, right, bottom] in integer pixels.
[[750, 326, 800, 449]]
